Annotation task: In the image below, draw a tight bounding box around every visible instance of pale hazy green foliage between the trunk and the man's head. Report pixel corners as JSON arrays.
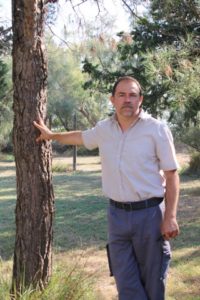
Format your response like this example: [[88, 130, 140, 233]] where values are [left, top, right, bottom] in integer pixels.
[[48, 34, 108, 130]]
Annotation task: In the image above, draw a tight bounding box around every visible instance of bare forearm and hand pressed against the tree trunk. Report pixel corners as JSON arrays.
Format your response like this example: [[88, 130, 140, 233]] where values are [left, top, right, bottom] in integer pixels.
[[33, 119, 83, 146]]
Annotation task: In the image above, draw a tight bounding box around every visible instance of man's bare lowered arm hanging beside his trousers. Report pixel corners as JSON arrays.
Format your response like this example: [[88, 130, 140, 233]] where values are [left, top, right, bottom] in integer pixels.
[[161, 170, 179, 240]]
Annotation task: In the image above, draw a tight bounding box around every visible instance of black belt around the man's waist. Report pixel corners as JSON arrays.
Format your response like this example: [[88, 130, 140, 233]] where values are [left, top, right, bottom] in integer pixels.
[[110, 197, 163, 211]]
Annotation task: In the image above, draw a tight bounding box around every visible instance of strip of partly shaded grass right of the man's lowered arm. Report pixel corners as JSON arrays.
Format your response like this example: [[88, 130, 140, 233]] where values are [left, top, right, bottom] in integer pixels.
[[167, 176, 200, 300]]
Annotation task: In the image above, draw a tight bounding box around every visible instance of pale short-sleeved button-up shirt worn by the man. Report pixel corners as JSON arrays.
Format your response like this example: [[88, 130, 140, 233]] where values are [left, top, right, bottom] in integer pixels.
[[82, 111, 178, 202]]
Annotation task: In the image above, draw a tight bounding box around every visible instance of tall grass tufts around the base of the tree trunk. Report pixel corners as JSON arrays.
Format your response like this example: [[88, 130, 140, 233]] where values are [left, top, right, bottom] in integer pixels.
[[0, 261, 96, 300]]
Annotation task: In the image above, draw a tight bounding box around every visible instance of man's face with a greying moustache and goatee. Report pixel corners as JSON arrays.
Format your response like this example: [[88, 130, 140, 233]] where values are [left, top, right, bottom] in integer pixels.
[[110, 80, 143, 119]]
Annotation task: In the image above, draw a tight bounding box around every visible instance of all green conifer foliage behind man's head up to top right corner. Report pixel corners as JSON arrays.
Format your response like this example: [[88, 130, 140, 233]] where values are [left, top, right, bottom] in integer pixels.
[[83, 0, 200, 126]]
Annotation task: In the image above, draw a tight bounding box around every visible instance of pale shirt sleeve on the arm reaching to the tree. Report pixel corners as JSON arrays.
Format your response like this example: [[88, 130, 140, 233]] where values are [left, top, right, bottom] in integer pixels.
[[82, 125, 98, 150]]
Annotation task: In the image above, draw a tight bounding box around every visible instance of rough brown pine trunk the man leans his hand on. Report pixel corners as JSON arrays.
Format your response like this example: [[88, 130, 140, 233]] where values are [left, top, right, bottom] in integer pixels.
[[11, 0, 54, 294]]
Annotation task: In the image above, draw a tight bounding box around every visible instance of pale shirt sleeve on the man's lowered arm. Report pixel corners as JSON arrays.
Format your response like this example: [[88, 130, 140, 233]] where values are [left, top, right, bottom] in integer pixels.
[[156, 123, 179, 171]]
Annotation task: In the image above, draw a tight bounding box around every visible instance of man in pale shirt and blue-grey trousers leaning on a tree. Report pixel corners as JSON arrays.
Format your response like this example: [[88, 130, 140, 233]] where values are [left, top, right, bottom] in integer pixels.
[[34, 76, 179, 300]]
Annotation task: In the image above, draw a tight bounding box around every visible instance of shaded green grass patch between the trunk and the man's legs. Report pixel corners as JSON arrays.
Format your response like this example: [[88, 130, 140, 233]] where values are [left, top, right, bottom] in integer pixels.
[[54, 195, 107, 251]]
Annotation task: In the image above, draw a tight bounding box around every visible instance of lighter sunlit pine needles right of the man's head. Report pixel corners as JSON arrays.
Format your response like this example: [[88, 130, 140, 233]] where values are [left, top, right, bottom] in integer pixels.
[[144, 36, 200, 123]]
